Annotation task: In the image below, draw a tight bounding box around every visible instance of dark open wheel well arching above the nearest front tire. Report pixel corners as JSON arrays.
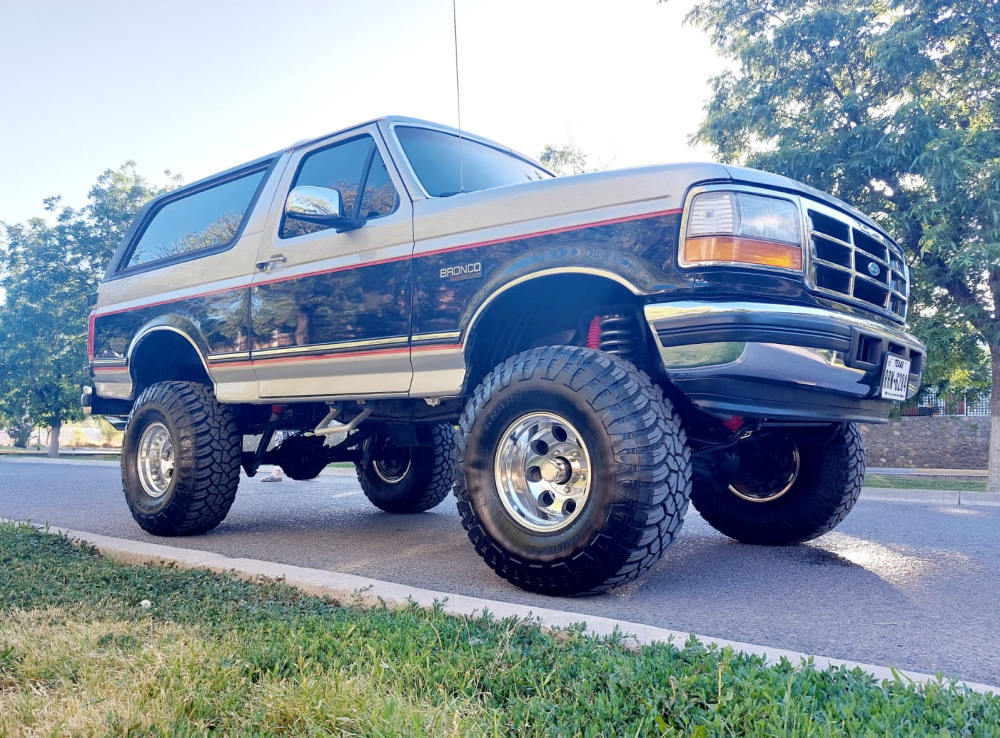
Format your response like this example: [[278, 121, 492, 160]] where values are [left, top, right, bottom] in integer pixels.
[[466, 274, 648, 390]]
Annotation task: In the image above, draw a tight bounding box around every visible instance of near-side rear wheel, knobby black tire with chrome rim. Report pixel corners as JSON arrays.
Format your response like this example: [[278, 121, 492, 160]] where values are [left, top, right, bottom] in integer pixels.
[[122, 382, 243, 536]]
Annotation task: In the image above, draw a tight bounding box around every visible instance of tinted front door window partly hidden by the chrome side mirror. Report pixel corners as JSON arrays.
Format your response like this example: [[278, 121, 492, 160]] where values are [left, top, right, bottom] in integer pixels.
[[279, 136, 397, 238]]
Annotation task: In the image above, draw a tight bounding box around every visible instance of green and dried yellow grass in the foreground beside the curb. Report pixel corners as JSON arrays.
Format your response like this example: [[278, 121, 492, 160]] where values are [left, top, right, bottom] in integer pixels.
[[0, 525, 1000, 736]]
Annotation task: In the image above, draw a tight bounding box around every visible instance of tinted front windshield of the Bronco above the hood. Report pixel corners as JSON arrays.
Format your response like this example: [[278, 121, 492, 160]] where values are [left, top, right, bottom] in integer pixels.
[[395, 126, 552, 197]]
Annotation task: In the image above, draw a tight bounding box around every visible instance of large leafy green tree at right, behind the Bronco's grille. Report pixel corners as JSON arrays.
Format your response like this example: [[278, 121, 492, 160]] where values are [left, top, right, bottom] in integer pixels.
[[684, 0, 1000, 491]]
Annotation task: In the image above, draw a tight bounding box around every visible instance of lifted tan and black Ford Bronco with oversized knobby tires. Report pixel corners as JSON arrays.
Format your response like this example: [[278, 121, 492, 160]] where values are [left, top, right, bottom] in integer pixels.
[[83, 117, 924, 595]]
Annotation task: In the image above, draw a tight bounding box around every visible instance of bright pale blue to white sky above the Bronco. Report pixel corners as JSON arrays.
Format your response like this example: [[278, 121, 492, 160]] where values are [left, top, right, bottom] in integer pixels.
[[0, 0, 722, 223]]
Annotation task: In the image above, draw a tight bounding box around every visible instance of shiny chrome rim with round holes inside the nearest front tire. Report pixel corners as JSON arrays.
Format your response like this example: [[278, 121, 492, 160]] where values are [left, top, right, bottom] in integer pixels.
[[494, 412, 592, 533]]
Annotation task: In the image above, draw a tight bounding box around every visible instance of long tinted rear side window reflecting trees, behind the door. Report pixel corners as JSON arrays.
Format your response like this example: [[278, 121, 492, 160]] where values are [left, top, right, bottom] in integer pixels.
[[125, 169, 266, 269]]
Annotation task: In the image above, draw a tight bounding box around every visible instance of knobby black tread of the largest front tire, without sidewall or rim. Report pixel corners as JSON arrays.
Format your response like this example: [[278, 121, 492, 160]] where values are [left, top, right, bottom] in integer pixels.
[[455, 346, 691, 595]]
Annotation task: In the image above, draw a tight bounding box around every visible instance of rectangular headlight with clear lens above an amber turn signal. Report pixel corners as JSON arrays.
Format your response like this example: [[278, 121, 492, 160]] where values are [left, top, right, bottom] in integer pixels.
[[681, 191, 802, 271]]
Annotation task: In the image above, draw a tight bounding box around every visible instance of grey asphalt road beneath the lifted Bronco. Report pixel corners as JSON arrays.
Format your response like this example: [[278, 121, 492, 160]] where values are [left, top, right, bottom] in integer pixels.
[[0, 461, 1000, 685]]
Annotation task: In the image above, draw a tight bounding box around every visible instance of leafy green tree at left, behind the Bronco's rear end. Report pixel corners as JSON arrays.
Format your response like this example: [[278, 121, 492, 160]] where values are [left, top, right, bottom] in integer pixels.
[[0, 162, 172, 456]]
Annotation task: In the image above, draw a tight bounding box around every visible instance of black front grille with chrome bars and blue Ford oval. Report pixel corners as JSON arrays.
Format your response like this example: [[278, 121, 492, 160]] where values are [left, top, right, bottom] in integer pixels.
[[809, 208, 909, 320]]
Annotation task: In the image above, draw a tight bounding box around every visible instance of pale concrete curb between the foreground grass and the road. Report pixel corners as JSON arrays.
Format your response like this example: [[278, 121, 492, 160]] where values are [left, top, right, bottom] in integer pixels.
[[0, 518, 1000, 695]]
